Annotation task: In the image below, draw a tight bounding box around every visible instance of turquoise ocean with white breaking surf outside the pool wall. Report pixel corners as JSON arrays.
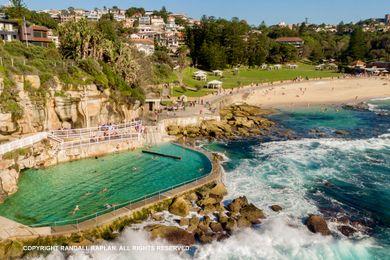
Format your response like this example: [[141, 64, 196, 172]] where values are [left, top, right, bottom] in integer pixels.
[[49, 99, 390, 259]]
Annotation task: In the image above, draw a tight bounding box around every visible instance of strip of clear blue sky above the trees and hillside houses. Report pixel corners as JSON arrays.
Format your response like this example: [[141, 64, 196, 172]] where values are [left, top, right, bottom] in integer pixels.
[[0, 0, 390, 24]]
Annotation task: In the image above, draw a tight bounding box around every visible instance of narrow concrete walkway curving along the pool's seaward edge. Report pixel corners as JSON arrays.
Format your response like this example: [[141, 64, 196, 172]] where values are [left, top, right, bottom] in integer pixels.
[[0, 147, 222, 241]]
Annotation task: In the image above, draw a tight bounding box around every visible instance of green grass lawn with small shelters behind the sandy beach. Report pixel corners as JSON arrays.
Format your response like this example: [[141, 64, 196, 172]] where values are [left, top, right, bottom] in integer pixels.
[[173, 63, 340, 97]]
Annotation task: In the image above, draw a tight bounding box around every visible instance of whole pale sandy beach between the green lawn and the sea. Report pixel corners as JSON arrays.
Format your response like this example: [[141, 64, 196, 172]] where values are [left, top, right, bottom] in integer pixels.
[[197, 77, 390, 112]]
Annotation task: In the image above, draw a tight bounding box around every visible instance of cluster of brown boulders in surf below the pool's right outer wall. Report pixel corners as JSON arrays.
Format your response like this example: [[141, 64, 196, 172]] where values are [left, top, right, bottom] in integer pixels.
[[144, 183, 266, 246]]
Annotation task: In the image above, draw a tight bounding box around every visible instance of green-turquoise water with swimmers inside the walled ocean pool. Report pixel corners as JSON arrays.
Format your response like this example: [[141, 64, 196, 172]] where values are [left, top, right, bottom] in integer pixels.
[[0, 144, 211, 225]]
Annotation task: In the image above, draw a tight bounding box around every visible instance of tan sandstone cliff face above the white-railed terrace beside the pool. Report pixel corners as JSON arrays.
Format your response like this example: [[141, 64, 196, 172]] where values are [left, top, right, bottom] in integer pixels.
[[0, 75, 139, 137]]
